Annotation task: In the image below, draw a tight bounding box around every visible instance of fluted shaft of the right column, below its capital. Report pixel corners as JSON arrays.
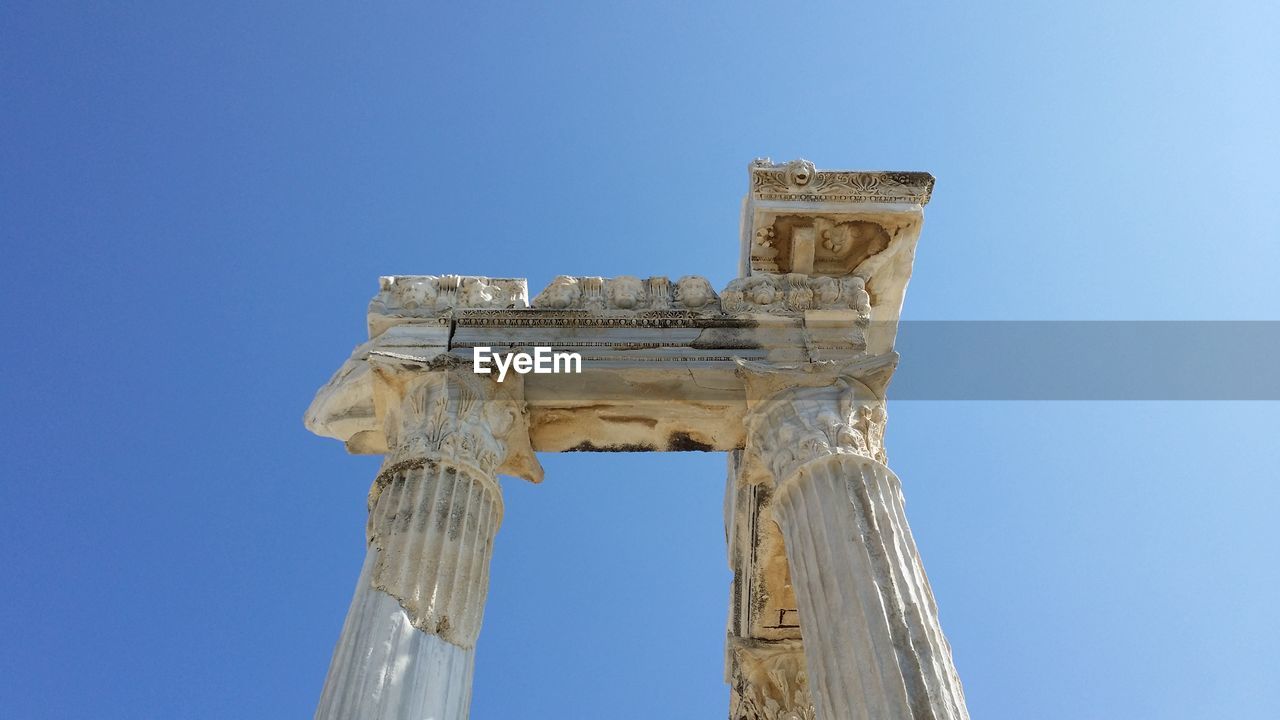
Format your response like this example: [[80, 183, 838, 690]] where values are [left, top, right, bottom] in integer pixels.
[[774, 454, 969, 720]]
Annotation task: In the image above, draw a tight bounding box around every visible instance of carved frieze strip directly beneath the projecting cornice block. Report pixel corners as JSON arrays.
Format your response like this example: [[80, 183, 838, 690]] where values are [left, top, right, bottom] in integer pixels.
[[721, 273, 872, 313]]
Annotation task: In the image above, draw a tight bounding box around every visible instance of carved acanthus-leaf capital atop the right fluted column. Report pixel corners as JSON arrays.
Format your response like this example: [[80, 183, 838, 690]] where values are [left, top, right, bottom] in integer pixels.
[[746, 378, 886, 483]]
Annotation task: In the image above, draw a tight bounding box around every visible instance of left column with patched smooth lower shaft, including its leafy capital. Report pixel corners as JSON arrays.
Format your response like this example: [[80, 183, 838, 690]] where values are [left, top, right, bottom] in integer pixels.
[[315, 365, 527, 720]]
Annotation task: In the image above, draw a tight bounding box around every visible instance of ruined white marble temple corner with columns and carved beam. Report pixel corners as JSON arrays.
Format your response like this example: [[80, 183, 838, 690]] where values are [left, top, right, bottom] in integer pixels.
[[306, 160, 968, 720]]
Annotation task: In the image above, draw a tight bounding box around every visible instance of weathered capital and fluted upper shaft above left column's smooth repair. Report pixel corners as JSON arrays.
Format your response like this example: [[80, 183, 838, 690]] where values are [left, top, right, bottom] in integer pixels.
[[367, 368, 541, 648]]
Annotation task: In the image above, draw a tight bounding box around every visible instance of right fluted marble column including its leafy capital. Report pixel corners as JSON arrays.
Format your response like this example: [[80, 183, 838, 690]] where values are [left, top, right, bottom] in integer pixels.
[[746, 373, 969, 720]]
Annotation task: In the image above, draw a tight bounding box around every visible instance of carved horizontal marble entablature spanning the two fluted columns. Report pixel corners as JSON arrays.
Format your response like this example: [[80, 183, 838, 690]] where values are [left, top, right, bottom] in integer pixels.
[[307, 273, 896, 454]]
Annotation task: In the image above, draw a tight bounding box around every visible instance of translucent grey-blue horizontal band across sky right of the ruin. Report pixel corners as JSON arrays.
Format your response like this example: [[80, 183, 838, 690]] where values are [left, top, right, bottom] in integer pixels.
[[888, 320, 1280, 400]]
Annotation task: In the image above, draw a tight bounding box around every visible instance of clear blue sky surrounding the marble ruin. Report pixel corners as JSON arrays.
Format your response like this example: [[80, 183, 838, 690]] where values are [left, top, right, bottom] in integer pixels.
[[0, 0, 1280, 720]]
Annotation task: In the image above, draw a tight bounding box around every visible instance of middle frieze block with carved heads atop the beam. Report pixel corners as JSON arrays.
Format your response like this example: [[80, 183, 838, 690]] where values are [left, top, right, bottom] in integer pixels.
[[532, 275, 719, 314]]
